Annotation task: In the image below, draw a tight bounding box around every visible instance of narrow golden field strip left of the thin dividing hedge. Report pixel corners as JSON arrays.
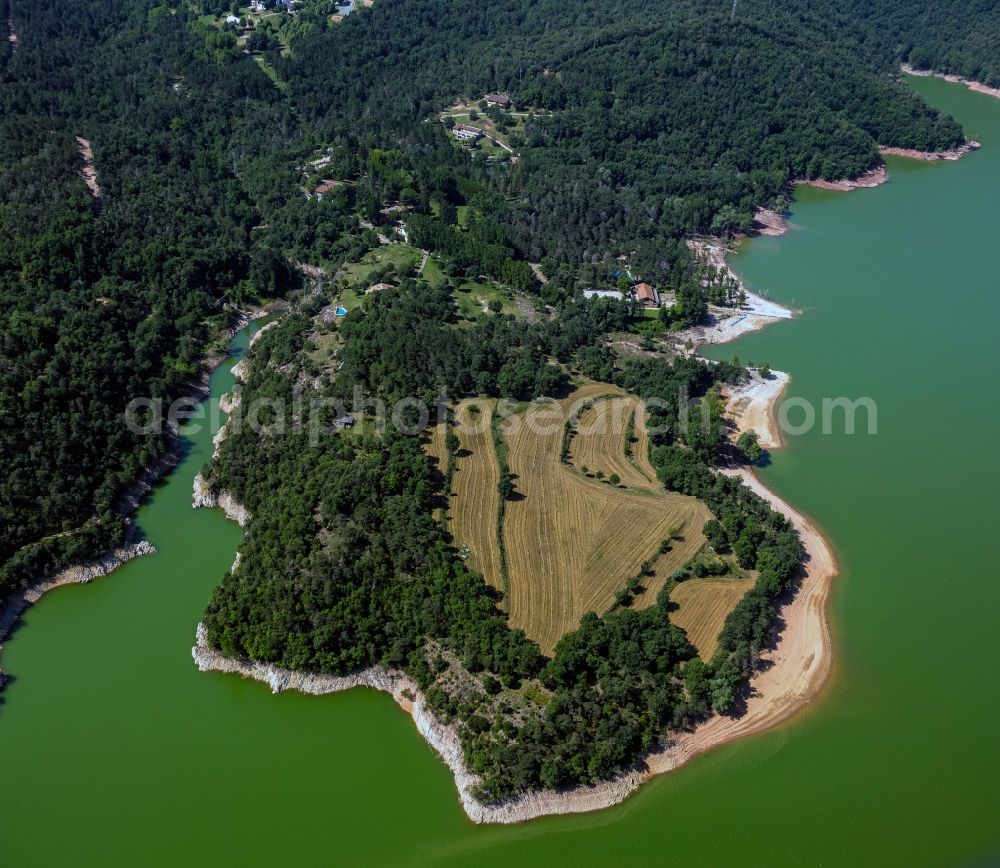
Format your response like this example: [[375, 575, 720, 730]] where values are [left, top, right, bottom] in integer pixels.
[[450, 399, 504, 590]]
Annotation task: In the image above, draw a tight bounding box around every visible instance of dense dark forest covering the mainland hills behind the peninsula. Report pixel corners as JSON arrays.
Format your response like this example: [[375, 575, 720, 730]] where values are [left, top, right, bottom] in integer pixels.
[[0, 0, 998, 586]]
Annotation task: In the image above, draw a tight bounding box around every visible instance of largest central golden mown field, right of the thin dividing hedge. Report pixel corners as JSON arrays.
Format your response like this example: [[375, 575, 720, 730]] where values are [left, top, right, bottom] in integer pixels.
[[502, 383, 710, 653]]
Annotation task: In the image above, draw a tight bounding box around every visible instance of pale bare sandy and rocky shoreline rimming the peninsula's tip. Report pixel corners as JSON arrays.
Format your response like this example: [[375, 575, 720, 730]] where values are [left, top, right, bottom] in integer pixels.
[[191, 362, 837, 824]]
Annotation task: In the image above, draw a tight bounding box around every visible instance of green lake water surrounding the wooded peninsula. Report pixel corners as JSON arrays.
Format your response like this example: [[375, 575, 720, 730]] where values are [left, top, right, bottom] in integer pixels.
[[0, 79, 1000, 866]]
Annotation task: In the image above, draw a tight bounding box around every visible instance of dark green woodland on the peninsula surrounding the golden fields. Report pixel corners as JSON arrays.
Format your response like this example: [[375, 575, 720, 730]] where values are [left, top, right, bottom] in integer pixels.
[[204, 294, 802, 800]]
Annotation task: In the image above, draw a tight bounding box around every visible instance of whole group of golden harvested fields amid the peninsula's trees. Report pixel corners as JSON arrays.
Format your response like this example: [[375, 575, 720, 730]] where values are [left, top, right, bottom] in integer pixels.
[[428, 383, 751, 659]]
